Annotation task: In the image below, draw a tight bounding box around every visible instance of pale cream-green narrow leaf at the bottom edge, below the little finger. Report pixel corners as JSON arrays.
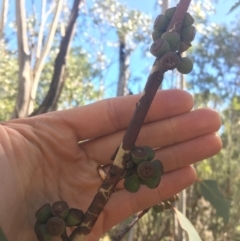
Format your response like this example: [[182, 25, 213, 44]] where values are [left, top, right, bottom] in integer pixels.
[[173, 208, 202, 241]]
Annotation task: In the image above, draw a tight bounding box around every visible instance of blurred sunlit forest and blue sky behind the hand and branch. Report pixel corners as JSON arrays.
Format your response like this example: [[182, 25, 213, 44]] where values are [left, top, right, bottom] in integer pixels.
[[0, 0, 240, 241]]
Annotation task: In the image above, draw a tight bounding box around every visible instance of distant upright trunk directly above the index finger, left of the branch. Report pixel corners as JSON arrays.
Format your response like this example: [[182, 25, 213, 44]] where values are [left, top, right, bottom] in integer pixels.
[[117, 34, 130, 96]]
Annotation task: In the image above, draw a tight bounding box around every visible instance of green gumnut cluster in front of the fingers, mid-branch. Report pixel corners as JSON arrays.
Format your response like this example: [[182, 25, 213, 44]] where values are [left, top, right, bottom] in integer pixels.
[[124, 146, 164, 193]]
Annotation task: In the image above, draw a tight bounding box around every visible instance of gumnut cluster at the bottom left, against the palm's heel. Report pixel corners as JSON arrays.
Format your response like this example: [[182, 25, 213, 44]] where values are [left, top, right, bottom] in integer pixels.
[[34, 201, 84, 241]]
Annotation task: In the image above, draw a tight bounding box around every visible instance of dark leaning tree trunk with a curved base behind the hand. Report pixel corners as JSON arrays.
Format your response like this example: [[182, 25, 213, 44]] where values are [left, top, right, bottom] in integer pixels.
[[31, 0, 82, 116]]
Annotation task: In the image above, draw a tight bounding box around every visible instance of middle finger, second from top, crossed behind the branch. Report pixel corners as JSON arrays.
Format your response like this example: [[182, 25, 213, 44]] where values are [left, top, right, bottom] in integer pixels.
[[81, 109, 221, 165]]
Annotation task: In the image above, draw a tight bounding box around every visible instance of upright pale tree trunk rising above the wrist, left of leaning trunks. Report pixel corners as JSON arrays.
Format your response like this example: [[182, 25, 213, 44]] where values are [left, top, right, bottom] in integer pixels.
[[12, 0, 31, 118]]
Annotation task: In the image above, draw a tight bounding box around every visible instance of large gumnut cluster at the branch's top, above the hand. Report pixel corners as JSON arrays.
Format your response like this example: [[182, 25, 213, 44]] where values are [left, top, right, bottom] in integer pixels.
[[150, 7, 196, 74]]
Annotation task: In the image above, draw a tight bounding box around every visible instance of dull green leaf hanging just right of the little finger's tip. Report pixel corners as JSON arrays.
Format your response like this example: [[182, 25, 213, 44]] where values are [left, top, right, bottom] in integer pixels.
[[200, 180, 230, 223]]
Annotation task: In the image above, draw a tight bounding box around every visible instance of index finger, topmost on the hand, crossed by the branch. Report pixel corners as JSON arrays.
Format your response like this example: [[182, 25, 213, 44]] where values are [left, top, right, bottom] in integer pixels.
[[54, 89, 193, 140]]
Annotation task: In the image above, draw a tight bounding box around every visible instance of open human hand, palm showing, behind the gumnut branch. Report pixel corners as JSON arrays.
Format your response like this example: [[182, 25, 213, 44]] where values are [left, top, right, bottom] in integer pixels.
[[0, 90, 221, 241]]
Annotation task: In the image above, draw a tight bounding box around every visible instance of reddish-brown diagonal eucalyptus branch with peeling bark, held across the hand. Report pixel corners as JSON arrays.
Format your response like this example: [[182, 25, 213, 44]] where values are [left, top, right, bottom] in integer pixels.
[[70, 0, 191, 241]]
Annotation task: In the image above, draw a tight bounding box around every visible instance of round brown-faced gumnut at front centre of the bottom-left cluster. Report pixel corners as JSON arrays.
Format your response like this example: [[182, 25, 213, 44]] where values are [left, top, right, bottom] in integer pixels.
[[47, 217, 66, 236]]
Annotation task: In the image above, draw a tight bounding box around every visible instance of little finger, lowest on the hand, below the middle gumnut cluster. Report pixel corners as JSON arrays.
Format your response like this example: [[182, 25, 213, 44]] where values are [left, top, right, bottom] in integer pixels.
[[99, 166, 196, 232]]
